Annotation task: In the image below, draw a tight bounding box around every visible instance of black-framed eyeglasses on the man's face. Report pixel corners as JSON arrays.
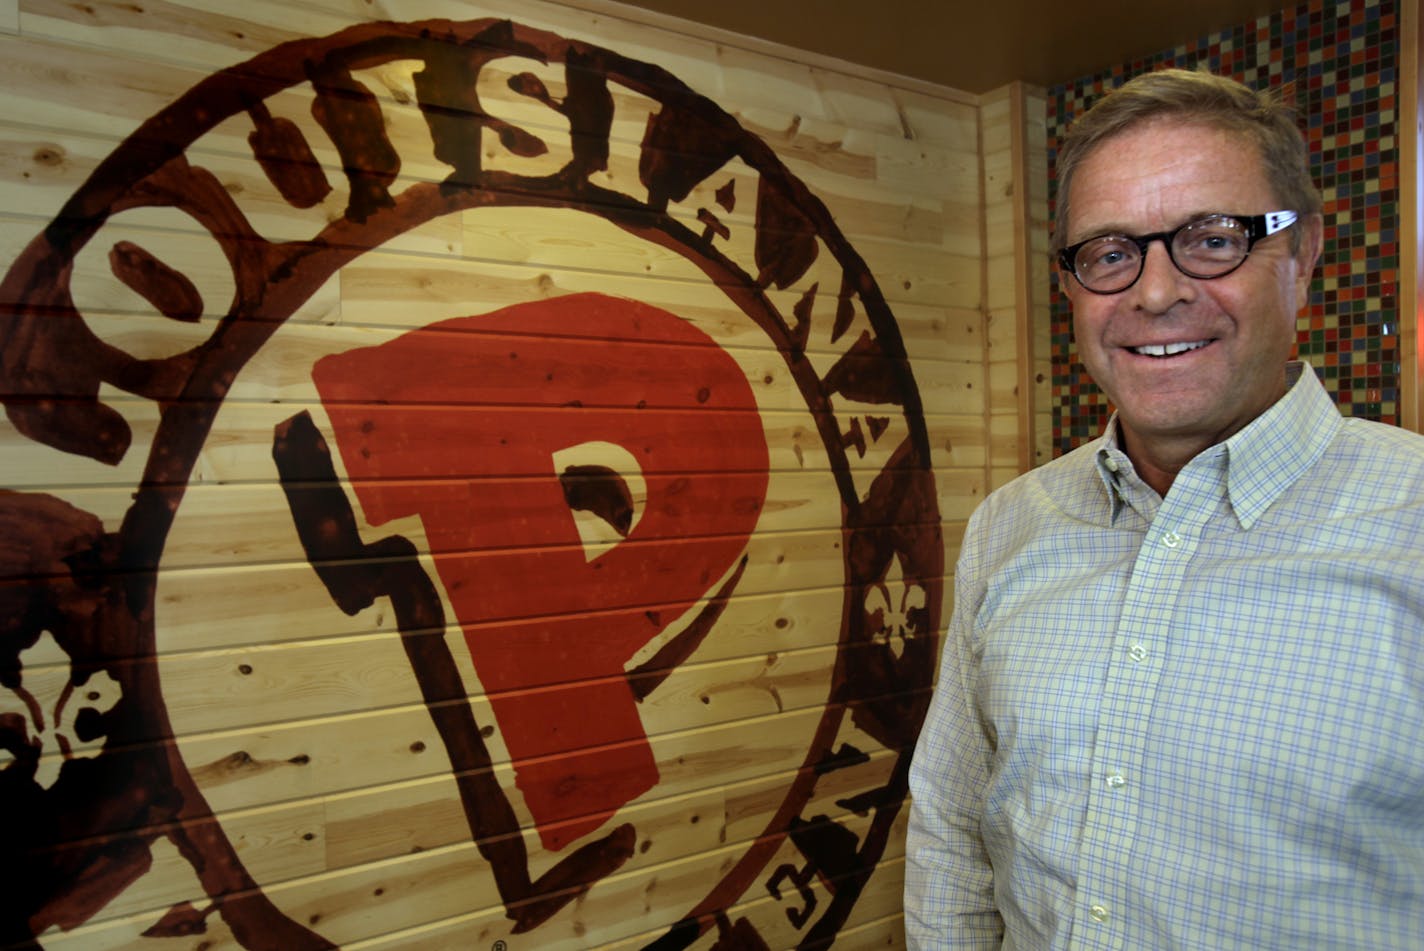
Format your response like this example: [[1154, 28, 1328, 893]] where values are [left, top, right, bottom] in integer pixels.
[[1058, 211, 1299, 293]]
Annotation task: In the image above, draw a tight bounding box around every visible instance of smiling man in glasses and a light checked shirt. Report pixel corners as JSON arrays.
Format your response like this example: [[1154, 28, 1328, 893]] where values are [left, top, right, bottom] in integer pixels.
[[906, 70, 1424, 951]]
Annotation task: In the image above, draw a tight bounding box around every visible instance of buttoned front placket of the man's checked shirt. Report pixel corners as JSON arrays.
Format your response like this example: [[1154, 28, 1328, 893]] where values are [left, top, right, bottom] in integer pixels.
[[1069, 491, 1210, 950]]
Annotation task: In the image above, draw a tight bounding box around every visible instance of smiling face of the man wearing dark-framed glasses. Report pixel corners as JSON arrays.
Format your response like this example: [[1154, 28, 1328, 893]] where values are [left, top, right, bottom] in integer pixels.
[[1062, 121, 1320, 458]]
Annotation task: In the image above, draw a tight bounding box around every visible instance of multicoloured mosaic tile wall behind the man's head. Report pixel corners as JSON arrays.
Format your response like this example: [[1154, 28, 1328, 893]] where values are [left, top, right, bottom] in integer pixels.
[[1048, 0, 1400, 454]]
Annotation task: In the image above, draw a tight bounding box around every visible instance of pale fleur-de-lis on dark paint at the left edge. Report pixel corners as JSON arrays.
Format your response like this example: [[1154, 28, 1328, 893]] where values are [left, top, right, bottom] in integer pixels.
[[0, 631, 124, 789]]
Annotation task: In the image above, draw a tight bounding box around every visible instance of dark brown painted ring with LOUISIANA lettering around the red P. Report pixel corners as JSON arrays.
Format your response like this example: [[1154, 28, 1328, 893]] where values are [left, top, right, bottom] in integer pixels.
[[0, 20, 943, 948]]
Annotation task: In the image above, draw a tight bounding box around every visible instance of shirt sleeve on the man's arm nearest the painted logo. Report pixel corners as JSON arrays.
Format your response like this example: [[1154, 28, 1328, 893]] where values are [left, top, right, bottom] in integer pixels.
[[904, 520, 1004, 951]]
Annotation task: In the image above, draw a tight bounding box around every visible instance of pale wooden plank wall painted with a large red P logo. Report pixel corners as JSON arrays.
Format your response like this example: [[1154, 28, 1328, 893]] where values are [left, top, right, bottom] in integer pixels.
[[0, 0, 1025, 951]]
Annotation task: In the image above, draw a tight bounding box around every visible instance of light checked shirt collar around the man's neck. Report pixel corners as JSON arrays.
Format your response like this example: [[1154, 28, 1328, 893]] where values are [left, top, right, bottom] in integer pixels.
[[1094, 360, 1343, 530]]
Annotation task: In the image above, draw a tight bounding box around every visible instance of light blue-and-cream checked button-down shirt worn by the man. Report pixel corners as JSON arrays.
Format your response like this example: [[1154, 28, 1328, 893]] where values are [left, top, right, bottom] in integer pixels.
[[906, 364, 1424, 951]]
